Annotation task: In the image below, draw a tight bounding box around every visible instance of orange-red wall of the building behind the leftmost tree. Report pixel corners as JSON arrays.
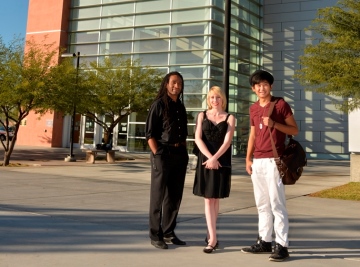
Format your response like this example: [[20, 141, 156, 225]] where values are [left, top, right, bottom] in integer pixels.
[[17, 0, 70, 147]]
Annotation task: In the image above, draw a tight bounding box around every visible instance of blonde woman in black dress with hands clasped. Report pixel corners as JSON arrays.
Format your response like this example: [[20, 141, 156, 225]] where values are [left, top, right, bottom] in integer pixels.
[[193, 86, 235, 253]]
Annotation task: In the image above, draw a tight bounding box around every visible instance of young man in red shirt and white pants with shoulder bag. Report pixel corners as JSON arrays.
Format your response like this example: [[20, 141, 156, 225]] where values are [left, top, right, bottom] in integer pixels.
[[241, 70, 298, 261]]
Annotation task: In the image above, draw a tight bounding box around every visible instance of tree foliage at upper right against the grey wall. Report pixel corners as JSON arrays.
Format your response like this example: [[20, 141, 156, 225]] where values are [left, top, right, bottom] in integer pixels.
[[295, 0, 360, 112]]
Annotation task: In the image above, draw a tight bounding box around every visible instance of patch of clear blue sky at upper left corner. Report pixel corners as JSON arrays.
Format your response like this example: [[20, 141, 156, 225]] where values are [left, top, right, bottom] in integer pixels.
[[0, 0, 29, 44]]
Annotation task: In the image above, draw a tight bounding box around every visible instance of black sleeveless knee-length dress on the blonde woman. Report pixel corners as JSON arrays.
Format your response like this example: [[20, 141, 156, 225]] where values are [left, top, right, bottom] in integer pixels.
[[193, 112, 231, 198]]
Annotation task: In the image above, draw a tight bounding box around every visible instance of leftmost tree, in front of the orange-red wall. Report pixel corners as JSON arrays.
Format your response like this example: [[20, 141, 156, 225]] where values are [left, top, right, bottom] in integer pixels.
[[0, 39, 62, 166]]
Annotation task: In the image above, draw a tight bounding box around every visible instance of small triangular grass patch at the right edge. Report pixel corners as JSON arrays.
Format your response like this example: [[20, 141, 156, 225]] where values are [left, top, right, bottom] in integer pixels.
[[309, 182, 360, 201]]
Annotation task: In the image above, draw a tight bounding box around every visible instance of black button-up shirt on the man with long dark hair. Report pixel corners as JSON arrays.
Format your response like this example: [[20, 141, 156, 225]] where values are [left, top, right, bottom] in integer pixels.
[[145, 97, 188, 144]]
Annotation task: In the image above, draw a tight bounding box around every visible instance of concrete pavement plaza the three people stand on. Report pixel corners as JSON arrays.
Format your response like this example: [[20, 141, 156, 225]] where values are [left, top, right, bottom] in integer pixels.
[[0, 147, 360, 267]]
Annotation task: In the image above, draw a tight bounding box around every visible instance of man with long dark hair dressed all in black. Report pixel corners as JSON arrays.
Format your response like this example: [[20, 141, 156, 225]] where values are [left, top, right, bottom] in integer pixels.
[[145, 72, 189, 249]]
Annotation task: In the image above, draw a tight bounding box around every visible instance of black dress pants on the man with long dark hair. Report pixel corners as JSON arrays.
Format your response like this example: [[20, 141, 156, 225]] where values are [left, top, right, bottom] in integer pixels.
[[149, 146, 189, 241]]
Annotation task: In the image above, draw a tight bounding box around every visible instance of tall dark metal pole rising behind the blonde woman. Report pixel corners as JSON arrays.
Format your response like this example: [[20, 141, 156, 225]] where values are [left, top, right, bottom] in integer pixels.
[[223, 0, 231, 111]]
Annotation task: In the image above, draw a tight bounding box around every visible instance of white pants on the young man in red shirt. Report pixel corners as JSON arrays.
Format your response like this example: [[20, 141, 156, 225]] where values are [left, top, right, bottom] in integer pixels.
[[251, 158, 289, 247]]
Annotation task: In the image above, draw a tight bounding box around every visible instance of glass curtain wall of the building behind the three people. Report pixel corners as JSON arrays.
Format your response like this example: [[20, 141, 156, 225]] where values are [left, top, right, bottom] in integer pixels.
[[69, 0, 262, 154]]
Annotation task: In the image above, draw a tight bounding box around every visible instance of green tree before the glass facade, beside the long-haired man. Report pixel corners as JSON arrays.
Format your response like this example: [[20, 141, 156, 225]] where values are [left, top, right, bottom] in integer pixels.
[[77, 55, 162, 144]]
